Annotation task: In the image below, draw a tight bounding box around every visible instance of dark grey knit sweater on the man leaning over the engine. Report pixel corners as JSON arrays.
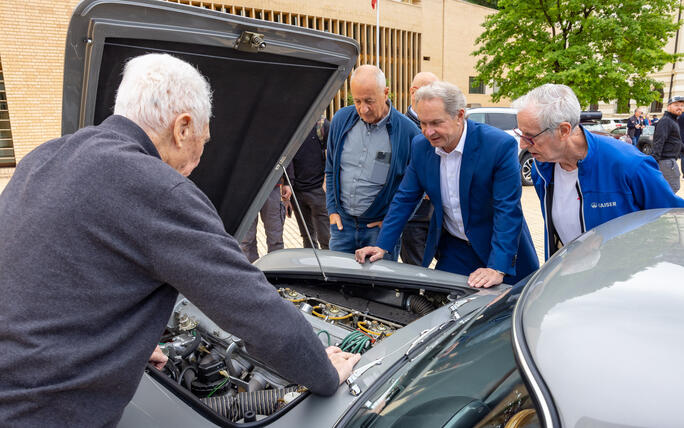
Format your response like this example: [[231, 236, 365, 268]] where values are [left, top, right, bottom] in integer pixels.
[[0, 116, 338, 427]]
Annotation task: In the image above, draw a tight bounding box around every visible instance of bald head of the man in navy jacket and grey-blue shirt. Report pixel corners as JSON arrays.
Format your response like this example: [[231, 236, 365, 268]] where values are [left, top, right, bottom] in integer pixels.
[[351, 65, 389, 123]]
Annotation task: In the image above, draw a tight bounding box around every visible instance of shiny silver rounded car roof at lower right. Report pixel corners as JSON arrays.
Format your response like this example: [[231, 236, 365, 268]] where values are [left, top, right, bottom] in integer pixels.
[[513, 208, 684, 426]]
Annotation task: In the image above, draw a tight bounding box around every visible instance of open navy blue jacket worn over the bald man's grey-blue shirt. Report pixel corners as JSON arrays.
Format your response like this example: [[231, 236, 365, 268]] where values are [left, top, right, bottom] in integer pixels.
[[325, 104, 420, 223]]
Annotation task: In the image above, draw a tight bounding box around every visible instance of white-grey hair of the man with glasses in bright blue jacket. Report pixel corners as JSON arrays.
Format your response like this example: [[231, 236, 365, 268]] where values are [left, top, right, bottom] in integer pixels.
[[513, 83, 582, 129]]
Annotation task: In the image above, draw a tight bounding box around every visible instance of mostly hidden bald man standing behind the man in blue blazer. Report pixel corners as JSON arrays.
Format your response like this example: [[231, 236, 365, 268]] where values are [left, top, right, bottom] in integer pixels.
[[400, 71, 439, 266]]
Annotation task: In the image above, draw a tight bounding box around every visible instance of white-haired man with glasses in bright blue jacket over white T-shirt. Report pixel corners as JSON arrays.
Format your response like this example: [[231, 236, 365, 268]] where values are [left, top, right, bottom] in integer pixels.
[[513, 84, 684, 259]]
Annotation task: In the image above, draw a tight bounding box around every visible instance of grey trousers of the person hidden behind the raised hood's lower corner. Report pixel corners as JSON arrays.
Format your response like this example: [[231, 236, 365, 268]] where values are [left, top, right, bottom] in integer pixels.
[[240, 187, 285, 262]]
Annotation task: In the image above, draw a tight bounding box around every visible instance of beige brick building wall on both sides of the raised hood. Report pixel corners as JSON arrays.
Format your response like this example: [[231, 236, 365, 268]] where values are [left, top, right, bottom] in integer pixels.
[[0, 0, 494, 178]]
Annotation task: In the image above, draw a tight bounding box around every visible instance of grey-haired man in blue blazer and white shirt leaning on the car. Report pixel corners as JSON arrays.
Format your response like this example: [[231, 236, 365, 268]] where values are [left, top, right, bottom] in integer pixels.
[[356, 82, 539, 287]]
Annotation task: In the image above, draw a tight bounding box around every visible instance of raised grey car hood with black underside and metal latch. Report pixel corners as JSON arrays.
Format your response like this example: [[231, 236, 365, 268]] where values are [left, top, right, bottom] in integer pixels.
[[62, 0, 359, 240]]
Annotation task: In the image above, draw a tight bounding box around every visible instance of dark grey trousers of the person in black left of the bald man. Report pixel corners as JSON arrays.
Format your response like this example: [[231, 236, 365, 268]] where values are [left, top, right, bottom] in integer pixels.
[[290, 187, 330, 250]]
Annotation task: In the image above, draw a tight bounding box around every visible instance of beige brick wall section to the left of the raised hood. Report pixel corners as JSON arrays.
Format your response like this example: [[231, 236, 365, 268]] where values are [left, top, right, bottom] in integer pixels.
[[0, 0, 78, 177]]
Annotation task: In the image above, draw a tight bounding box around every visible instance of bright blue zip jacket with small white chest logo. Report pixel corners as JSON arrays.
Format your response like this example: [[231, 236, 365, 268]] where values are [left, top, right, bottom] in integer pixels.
[[532, 126, 684, 259]]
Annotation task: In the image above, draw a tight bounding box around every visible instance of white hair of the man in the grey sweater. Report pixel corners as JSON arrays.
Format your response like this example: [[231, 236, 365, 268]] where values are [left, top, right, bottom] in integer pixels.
[[114, 54, 211, 133]]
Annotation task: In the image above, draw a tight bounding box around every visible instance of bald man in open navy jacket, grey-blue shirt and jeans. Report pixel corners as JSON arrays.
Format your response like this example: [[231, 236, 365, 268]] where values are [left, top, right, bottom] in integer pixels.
[[325, 65, 420, 260]]
